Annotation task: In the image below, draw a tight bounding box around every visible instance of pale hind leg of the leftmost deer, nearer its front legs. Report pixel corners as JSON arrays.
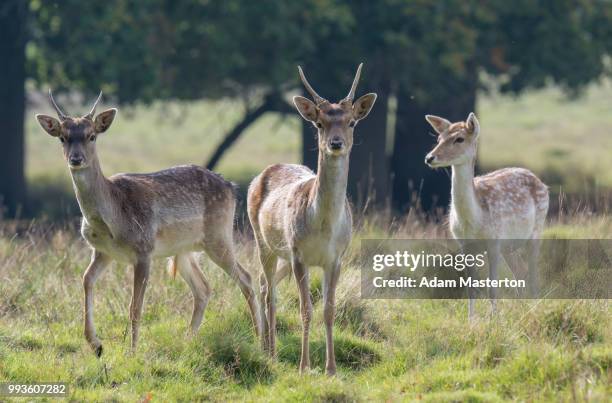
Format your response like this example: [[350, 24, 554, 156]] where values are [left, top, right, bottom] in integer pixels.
[[176, 253, 211, 333]]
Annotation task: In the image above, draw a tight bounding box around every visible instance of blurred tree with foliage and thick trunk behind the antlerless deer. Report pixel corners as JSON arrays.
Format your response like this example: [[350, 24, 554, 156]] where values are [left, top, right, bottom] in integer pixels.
[[344, 0, 612, 210]]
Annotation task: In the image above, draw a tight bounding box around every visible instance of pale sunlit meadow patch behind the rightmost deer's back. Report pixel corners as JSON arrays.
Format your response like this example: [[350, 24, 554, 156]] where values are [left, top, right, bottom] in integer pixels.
[[477, 81, 612, 193]]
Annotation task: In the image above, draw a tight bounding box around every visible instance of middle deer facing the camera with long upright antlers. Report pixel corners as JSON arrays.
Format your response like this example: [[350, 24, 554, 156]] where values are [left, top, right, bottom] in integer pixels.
[[247, 63, 376, 375]]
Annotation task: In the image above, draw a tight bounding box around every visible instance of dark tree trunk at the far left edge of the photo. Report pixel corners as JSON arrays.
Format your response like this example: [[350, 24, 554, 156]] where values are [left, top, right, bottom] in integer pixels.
[[0, 0, 27, 217]]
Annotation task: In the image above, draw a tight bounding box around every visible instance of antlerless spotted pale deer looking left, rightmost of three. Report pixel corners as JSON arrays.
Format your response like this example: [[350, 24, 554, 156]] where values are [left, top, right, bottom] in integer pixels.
[[425, 112, 549, 321]]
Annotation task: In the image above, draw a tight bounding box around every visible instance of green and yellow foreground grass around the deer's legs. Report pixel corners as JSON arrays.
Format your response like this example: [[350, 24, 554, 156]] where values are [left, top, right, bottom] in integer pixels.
[[0, 217, 612, 402]]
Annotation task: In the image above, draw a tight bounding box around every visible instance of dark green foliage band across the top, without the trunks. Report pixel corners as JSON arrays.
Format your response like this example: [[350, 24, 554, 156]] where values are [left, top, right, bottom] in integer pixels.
[[28, 0, 612, 103]]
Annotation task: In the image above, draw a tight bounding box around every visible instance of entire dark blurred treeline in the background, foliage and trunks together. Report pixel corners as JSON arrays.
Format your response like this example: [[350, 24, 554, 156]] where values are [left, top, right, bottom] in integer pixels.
[[0, 0, 612, 218]]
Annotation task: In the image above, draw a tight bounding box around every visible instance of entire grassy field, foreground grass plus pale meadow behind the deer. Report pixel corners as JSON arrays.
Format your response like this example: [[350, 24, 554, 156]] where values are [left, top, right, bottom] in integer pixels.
[[0, 83, 612, 402]]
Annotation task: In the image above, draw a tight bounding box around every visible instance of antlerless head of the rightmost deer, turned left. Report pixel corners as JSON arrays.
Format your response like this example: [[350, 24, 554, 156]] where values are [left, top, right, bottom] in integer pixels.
[[425, 112, 480, 168]]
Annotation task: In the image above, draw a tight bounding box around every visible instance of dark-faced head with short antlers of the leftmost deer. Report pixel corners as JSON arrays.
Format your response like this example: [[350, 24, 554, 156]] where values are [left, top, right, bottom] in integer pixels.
[[36, 90, 117, 169]]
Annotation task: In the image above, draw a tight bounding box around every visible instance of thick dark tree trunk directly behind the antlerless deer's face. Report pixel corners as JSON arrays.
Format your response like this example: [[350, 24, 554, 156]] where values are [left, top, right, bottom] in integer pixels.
[[391, 73, 477, 216]]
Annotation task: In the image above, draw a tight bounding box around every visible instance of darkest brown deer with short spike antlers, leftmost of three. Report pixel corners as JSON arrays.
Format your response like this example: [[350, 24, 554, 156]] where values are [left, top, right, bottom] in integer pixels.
[[36, 90, 260, 357]]
